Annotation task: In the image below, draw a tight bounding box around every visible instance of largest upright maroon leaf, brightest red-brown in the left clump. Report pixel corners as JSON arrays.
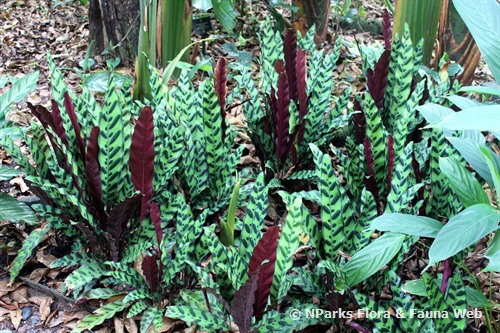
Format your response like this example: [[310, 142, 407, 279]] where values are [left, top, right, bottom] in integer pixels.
[[130, 106, 155, 221]]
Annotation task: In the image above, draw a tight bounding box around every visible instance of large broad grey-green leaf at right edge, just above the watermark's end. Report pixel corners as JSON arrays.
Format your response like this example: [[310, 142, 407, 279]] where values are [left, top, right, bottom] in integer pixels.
[[428, 204, 500, 267]]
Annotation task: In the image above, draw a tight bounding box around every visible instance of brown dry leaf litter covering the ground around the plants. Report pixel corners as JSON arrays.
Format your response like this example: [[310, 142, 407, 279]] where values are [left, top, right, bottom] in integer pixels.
[[0, 0, 500, 333]]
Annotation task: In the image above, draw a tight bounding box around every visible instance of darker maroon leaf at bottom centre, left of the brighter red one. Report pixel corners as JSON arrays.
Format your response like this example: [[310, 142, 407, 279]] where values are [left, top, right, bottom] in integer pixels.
[[230, 267, 261, 333]]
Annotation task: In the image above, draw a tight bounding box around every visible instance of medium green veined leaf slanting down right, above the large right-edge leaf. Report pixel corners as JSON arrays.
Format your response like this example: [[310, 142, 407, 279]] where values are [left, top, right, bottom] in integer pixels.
[[439, 158, 490, 208]]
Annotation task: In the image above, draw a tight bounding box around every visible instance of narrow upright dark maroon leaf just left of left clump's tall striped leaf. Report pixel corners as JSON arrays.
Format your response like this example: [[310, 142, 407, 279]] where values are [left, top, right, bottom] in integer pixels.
[[85, 126, 106, 224]]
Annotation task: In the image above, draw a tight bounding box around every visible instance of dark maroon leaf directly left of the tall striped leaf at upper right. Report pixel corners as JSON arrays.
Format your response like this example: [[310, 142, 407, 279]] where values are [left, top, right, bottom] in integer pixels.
[[366, 50, 391, 110]]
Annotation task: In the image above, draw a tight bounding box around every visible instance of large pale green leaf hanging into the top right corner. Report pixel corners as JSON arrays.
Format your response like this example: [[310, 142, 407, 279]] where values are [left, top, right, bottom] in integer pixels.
[[453, 0, 500, 82]]
